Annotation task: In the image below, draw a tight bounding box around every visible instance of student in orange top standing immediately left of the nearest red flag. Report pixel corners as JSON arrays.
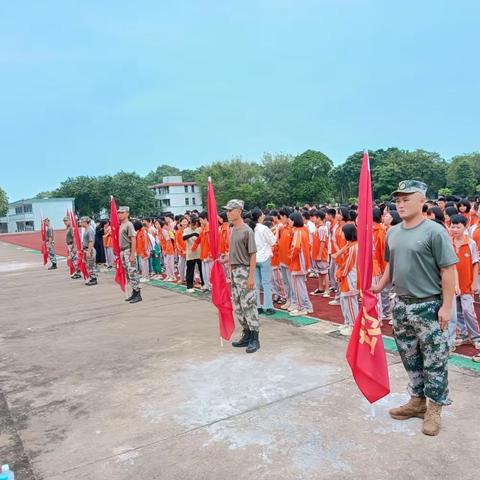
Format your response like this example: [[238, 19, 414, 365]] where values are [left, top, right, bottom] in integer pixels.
[[333, 223, 359, 336]]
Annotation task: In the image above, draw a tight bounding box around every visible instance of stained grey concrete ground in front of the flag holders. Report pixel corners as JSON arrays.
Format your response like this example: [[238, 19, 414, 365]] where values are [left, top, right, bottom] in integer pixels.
[[0, 243, 480, 480]]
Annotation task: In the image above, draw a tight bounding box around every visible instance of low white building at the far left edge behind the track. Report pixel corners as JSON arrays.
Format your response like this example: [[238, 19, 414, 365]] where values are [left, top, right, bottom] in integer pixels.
[[0, 198, 75, 233]]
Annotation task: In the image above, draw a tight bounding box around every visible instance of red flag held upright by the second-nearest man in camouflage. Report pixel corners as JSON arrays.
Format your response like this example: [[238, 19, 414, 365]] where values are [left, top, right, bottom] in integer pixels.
[[208, 177, 235, 340]]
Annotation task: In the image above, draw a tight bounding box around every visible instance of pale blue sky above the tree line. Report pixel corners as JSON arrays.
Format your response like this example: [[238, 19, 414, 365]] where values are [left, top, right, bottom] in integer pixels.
[[0, 0, 480, 200]]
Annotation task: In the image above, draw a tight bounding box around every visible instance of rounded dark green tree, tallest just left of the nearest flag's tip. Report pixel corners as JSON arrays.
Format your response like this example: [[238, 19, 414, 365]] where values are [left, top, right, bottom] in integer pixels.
[[289, 150, 333, 204]]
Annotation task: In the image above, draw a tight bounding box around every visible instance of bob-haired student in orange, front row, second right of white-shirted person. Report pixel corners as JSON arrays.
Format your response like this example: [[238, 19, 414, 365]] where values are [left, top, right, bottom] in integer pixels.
[[288, 212, 313, 317]]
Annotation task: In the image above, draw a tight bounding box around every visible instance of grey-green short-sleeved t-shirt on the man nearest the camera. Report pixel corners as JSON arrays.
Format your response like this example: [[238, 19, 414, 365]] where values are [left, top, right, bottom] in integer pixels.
[[385, 220, 458, 298]]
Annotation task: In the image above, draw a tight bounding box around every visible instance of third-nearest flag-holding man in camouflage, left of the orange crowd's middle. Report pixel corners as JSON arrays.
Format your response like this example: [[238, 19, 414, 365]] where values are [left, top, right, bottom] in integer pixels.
[[117, 207, 142, 303]]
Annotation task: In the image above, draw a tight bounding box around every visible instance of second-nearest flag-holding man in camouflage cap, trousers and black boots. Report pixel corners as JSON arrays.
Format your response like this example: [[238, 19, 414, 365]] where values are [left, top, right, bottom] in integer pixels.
[[220, 200, 260, 353]]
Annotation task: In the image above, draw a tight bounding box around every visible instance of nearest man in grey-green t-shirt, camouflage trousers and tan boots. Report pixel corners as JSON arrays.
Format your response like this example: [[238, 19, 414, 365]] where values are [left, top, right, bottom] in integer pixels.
[[372, 180, 457, 435]]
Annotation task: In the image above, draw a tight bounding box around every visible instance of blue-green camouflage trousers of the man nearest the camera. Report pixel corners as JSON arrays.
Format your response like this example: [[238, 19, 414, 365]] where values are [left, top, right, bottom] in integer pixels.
[[393, 297, 451, 405]]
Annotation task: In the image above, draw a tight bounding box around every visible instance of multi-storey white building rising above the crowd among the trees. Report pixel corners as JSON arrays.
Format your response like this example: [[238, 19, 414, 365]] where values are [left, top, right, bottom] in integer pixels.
[[151, 176, 203, 215]]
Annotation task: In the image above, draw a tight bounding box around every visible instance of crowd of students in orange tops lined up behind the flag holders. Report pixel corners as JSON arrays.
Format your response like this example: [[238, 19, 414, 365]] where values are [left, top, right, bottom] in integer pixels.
[[57, 193, 480, 361]]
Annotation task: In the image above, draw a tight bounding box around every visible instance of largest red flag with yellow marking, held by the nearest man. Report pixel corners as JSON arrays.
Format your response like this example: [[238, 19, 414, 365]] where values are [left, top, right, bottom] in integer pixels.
[[347, 151, 390, 403]]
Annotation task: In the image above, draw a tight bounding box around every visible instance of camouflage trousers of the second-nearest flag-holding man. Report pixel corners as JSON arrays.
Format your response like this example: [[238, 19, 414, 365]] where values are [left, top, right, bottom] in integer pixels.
[[232, 265, 260, 332]]
